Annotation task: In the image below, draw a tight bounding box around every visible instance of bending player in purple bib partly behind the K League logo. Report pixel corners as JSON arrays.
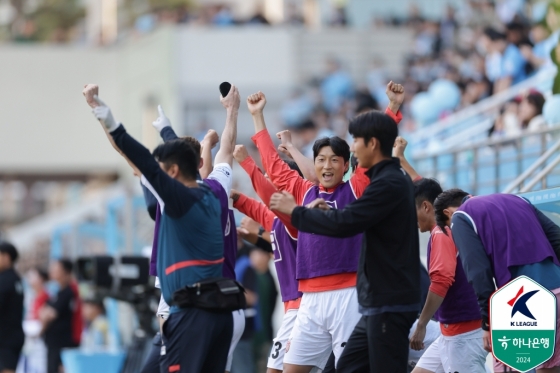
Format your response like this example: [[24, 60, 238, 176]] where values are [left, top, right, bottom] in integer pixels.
[[434, 189, 560, 373]]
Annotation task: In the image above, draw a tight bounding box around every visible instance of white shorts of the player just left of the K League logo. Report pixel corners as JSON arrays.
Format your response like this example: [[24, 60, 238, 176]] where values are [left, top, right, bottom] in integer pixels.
[[416, 329, 488, 373]]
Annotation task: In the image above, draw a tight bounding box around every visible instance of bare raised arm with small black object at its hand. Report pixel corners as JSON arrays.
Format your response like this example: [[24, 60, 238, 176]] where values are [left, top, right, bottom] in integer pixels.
[[215, 85, 240, 167]]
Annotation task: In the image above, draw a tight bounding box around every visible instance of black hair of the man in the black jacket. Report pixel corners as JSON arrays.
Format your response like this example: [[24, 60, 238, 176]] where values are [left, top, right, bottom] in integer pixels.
[[348, 110, 399, 157]]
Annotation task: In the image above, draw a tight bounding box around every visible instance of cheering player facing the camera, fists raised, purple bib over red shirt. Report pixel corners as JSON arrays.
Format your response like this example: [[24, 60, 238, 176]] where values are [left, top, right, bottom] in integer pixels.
[[247, 82, 404, 373]]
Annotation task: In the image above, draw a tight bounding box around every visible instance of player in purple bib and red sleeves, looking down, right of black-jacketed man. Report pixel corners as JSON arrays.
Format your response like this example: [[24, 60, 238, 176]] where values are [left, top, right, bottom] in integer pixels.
[[410, 178, 488, 373]]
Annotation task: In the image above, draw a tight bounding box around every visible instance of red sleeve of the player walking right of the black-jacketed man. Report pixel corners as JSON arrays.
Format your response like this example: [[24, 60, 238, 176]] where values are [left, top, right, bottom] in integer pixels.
[[429, 229, 457, 297]]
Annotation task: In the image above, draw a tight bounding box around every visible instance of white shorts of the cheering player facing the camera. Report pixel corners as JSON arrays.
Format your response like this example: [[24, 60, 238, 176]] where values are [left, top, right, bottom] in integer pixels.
[[284, 287, 361, 369]]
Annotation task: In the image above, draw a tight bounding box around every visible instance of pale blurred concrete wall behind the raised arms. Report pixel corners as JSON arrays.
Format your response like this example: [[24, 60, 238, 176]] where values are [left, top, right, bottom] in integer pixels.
[[0, 27, 411, 174]]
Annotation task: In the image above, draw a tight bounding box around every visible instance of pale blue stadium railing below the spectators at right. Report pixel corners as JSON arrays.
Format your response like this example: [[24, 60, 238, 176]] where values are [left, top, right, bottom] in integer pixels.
[[413, 126, 560, 195]]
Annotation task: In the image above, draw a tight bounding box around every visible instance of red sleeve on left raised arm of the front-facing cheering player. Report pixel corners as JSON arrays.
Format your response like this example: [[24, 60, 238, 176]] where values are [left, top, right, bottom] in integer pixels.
[[251, 130, 315, 205]]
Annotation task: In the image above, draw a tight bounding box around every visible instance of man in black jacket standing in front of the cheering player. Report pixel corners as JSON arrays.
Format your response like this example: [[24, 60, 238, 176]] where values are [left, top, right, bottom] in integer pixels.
[[270, 107, 420, 372]]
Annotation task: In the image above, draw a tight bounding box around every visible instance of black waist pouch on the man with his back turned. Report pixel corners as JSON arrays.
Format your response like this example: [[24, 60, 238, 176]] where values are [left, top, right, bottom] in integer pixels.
[[173, 277, 247, 312]]
